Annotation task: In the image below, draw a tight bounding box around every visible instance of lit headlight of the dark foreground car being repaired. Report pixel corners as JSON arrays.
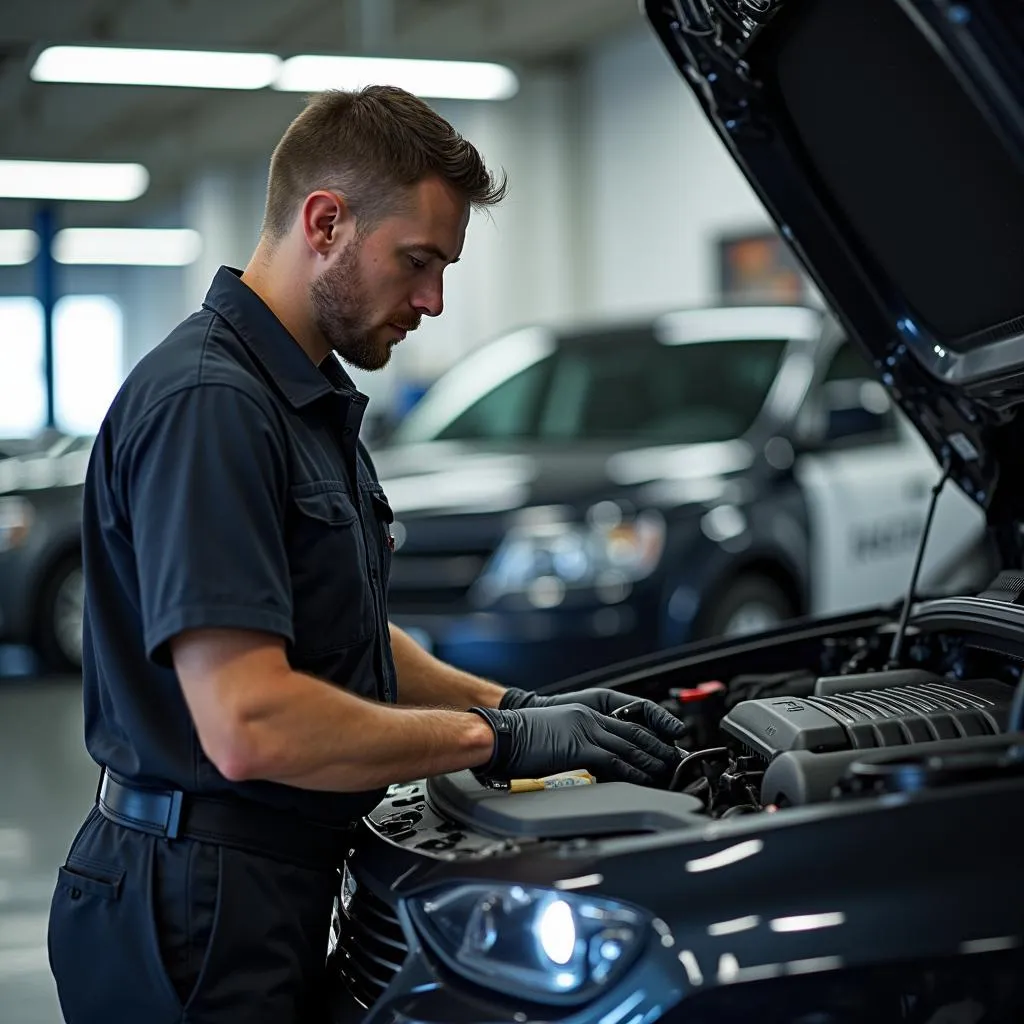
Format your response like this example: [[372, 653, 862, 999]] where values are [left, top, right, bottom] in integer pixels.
[[409, 883, 648, 1004]]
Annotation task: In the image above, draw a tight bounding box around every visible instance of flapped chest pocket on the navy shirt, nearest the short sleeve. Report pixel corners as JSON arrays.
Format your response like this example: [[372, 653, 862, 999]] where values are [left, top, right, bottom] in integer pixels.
[[286, 481, 374, 653]]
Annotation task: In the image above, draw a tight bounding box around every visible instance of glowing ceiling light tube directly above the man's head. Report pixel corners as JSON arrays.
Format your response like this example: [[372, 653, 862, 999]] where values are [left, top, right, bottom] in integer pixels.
[[273, 54, 519, 99]]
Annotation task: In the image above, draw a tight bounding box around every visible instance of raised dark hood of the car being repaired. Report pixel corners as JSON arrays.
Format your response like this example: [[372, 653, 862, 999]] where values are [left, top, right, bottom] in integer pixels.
[[642, 0, 1024, 563]]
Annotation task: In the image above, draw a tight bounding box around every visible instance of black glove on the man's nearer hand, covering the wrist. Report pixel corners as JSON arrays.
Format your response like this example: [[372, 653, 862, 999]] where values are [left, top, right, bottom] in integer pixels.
[[470, 703, 679, 785]]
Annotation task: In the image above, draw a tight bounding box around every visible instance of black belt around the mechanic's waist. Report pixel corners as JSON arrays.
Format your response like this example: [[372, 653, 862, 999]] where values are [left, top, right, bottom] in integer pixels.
[[96, 768, 356, 869]]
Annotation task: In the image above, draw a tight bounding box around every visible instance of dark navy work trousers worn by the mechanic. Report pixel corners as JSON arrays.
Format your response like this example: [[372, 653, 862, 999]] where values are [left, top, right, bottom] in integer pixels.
[[49, 808, 339, 1024]]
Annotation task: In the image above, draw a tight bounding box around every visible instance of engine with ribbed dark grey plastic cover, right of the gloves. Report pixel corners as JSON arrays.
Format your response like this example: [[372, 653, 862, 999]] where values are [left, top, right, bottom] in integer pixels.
[[663, 670, 1014, 817]]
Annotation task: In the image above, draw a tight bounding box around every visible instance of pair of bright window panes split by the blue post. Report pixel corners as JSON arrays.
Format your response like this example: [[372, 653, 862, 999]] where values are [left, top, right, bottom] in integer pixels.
[[0, 295, 124, 437]]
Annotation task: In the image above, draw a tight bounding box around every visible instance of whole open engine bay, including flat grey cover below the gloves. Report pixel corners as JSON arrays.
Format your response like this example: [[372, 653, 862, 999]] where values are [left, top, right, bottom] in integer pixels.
[[371, 617, 1024, 855]]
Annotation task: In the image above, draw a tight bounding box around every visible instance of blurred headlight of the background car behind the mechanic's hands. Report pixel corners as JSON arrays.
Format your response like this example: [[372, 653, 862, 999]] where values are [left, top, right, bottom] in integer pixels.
[[474, 501, 665, 607]]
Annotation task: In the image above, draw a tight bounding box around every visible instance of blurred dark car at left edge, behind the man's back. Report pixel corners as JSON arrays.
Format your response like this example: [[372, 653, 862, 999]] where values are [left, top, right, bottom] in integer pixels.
[[0, 435, 92, 672]]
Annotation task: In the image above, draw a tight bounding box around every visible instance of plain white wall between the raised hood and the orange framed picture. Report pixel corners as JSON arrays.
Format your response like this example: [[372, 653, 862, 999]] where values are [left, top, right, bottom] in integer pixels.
[[581, 28, 768, 312]]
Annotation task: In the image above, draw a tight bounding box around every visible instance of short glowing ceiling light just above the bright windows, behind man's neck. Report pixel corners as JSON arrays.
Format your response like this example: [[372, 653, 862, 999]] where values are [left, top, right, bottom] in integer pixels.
[[53, 227, 203, 266]]
